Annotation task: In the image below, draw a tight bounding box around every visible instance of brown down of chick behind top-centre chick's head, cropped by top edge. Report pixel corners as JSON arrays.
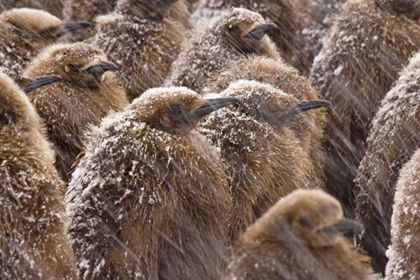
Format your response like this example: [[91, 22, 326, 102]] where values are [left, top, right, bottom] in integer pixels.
[[193, 0, 302, 73]]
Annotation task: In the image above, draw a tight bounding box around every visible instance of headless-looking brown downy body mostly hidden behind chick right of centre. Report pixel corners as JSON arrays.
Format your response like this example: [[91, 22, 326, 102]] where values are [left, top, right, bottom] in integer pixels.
[[202, 57, 325, 187]]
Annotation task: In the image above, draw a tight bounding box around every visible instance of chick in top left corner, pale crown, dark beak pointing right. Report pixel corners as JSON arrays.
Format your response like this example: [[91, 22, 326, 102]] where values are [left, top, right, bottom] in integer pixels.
[[0, 8, 90, 81]]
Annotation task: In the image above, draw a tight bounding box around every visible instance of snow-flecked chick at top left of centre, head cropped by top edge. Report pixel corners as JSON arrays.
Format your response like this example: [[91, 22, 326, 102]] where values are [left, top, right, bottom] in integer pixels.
[[93, 0, 186, 101]]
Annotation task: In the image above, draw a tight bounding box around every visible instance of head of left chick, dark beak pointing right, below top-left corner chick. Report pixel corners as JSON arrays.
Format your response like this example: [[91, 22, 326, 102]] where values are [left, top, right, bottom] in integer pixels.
[[24, 42, 118, 88]]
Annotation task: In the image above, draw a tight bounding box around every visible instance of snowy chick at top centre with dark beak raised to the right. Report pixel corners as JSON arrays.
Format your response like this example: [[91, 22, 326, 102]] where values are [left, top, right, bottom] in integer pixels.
[[164, 8, 280, 90]]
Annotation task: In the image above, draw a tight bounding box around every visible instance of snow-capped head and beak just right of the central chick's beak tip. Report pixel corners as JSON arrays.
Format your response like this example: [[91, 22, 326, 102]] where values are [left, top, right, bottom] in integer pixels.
[[221, 80, 330, 127]]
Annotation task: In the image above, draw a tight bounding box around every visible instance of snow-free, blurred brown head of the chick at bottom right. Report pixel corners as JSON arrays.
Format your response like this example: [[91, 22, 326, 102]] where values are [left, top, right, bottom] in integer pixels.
[[253, 189, 363, 248]]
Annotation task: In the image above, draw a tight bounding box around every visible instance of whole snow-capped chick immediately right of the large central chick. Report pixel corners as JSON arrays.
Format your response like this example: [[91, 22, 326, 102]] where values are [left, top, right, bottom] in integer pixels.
[[199, 80, 329, 244]]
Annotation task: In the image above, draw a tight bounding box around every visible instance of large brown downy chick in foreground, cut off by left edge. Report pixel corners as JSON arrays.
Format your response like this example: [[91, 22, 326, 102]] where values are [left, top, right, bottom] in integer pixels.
[[0, 73, 77, 280]]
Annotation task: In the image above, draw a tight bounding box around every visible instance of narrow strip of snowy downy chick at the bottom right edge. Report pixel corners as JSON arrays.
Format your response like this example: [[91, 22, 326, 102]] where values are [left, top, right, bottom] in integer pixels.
[[385, 150, 420, 280]]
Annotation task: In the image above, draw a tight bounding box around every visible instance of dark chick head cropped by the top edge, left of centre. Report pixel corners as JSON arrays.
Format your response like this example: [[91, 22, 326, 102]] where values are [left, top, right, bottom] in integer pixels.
[[116, 0, 178, 20]]
